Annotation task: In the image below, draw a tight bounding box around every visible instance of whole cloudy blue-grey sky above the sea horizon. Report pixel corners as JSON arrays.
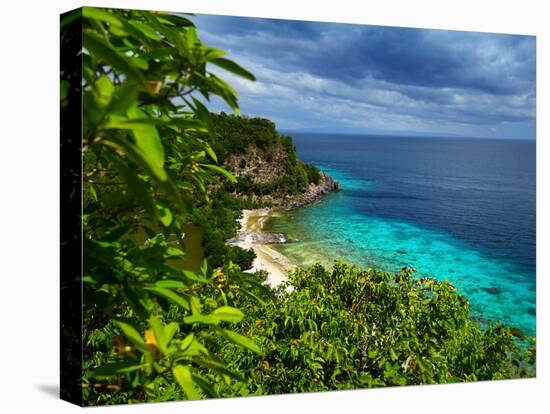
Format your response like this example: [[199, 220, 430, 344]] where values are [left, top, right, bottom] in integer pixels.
[[194, 15, 536, 139]]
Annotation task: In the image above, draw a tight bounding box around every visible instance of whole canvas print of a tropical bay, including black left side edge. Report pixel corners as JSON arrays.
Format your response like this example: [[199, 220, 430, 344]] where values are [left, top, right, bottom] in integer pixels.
[[60, 7, 536, 406]]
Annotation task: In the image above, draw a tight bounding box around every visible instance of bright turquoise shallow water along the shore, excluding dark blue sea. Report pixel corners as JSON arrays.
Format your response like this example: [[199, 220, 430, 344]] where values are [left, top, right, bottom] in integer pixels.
[[270, 137, 536, 335]]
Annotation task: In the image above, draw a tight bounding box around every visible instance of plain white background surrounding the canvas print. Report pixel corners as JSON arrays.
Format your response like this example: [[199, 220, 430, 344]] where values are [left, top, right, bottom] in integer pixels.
[[0, 0, 550, 413]]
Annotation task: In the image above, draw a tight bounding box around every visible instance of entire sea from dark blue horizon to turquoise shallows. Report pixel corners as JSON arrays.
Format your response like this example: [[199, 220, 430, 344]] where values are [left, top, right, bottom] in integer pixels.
[[271, 133, 536, 335]]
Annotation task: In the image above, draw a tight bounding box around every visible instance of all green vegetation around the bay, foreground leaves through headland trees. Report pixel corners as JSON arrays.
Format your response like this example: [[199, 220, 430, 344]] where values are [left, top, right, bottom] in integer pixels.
[[62, 8, 535, 405]]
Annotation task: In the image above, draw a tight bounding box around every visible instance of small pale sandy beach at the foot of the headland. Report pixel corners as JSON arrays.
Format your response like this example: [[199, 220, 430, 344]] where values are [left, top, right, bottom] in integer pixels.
[[231, 208, 295, 288]]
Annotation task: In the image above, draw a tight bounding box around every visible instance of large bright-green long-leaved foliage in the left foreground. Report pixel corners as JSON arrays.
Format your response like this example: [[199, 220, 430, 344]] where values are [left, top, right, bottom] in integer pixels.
[[69, 8, 270, 404]]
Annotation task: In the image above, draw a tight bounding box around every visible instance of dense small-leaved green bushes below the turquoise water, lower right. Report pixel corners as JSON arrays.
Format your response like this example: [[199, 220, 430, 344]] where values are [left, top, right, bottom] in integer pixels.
[[222, 263, 535, 394]]
